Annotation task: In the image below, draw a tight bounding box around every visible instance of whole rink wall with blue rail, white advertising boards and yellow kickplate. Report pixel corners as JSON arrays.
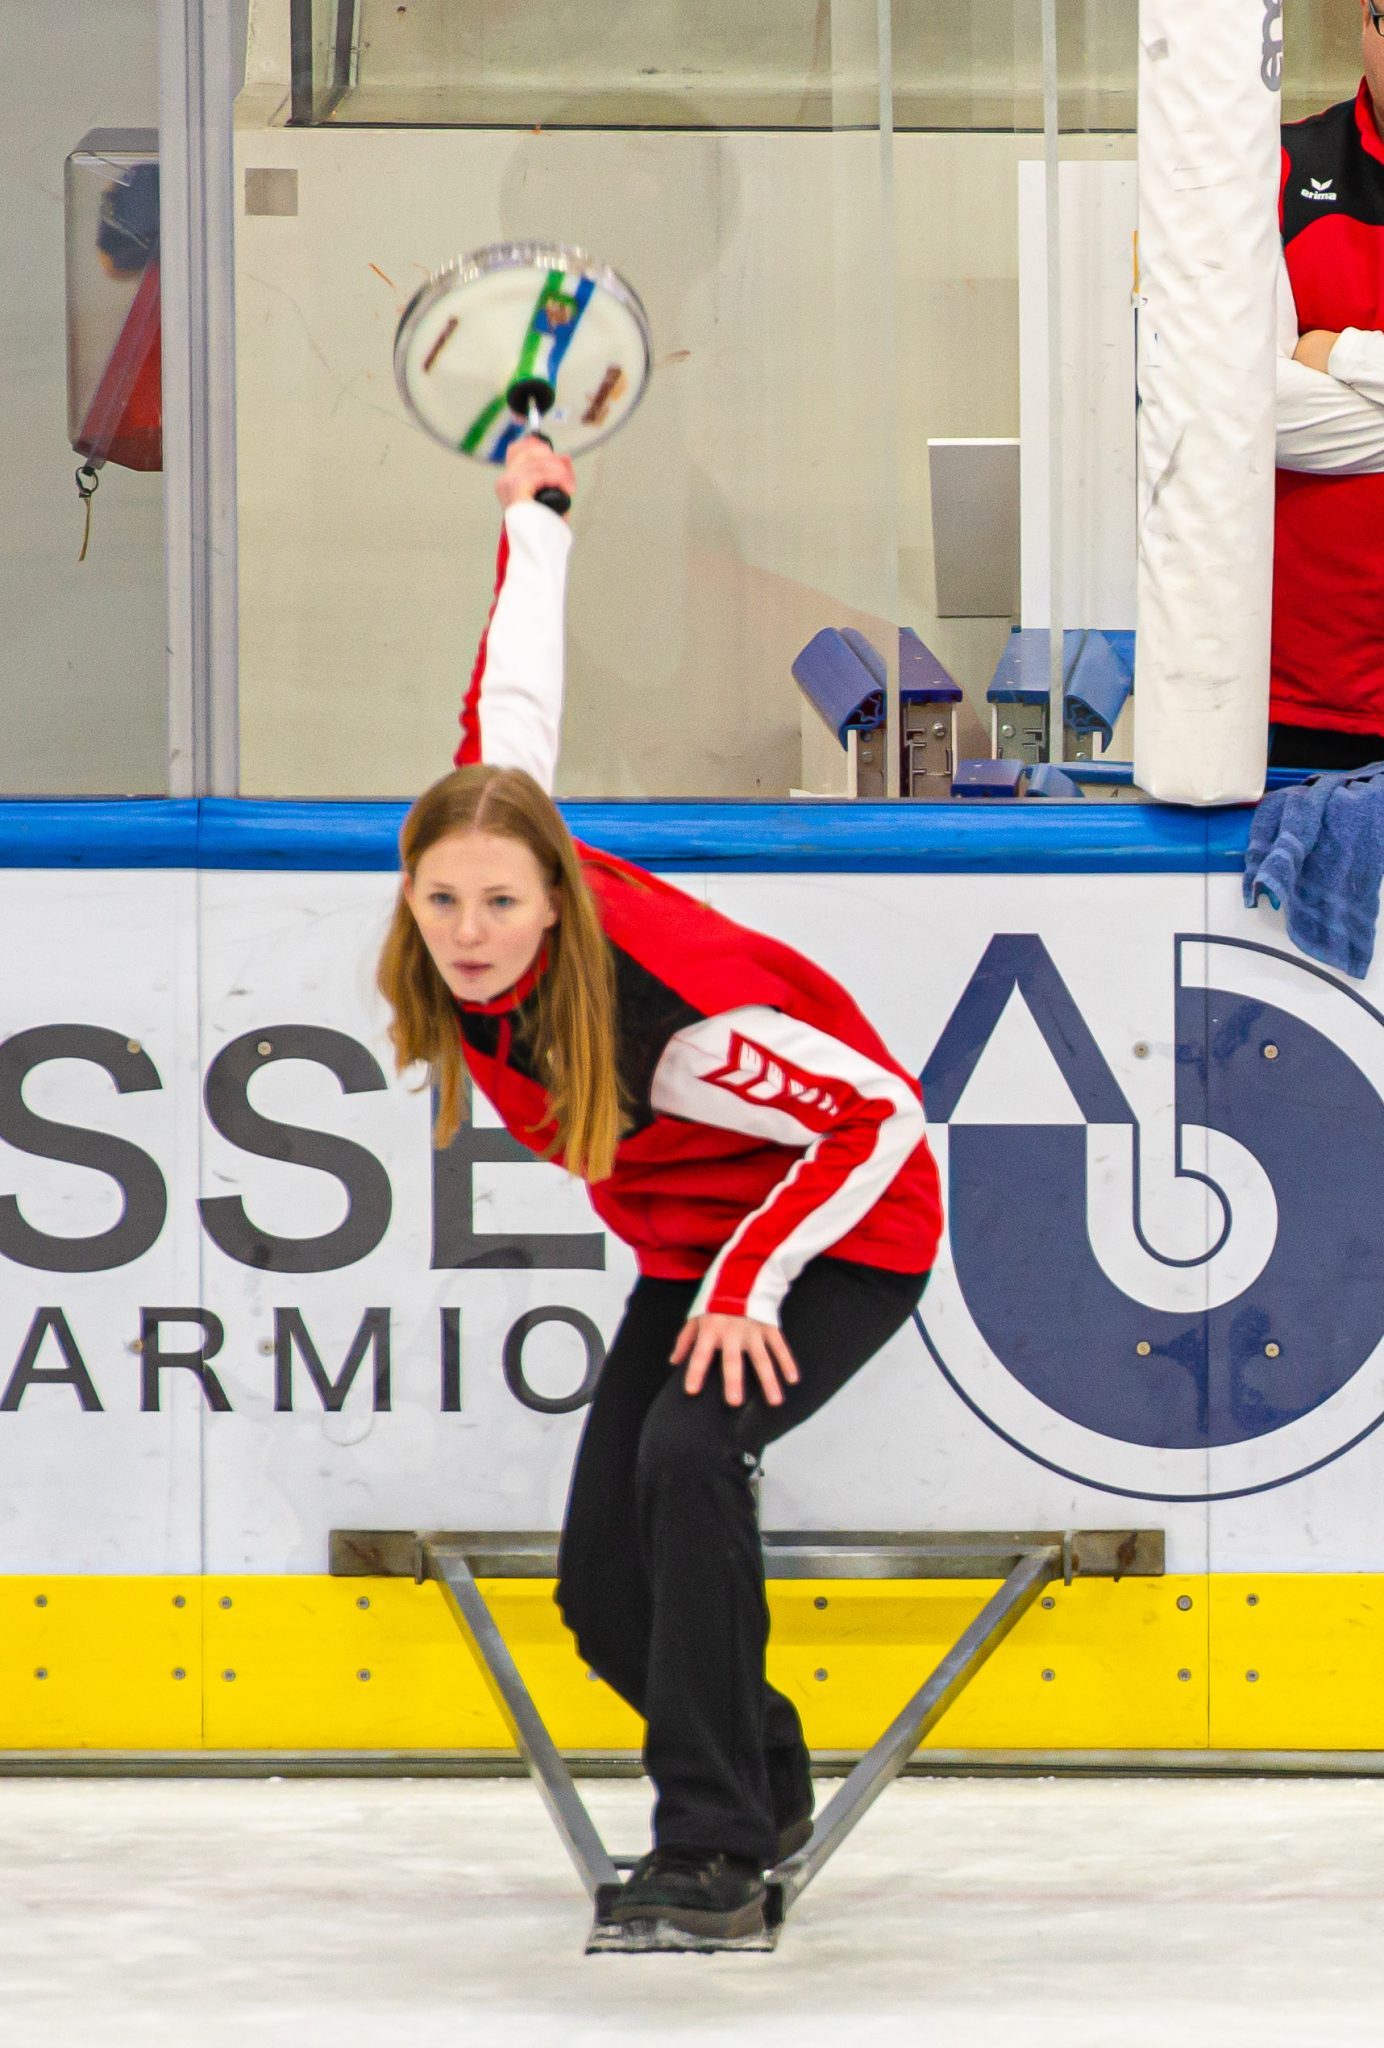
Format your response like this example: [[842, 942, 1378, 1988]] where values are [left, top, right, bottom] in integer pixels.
[[0, 801, 1384, 1753]]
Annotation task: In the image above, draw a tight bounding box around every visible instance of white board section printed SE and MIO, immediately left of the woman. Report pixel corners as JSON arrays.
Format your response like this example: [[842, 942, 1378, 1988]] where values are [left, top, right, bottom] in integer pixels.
[[201, 874, 633, 1571]]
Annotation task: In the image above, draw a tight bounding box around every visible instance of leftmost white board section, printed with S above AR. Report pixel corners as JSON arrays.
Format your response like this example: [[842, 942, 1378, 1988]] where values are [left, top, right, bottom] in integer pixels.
[[0, 868, 203, 1571]]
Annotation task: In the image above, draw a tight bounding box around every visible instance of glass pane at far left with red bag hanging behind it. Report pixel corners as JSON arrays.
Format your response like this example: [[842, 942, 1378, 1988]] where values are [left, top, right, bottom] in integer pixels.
[[0, 0, 168, 797]]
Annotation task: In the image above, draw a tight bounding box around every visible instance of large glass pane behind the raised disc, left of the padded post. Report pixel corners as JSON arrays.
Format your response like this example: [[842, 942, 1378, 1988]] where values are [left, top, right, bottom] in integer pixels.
[[237, 0, 1136, 799]]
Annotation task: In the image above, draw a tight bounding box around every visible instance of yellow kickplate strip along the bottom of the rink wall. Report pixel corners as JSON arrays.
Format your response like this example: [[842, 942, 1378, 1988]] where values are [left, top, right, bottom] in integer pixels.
[[0, 1573, 1384, 1753]]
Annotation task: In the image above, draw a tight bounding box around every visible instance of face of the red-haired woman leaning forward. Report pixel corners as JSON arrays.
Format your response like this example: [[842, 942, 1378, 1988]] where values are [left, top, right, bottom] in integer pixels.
[[403, 831, 557, 1004]]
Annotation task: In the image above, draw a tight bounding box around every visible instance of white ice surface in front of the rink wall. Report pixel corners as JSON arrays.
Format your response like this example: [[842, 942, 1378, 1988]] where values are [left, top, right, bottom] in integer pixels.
[[0, 1778, 1384, 2048]]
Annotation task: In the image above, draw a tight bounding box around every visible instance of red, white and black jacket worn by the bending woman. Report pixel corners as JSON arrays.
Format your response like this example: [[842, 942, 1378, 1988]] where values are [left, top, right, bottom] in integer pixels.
[[457, 504, 942, 1323]]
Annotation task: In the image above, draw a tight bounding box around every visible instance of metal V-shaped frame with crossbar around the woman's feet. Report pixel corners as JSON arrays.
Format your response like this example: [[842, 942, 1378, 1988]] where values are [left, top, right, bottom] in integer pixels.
[[332, 1530, 1163, 1954]]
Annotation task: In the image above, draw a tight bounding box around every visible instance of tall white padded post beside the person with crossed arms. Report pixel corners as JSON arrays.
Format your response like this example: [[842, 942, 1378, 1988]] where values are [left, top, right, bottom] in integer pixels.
[[1134, 0, 1282, 805]]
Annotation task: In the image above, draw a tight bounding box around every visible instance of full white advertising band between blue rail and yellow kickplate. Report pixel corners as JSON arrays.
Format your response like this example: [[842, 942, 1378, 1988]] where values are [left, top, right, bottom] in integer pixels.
[[0, 870, 1384, 1571]]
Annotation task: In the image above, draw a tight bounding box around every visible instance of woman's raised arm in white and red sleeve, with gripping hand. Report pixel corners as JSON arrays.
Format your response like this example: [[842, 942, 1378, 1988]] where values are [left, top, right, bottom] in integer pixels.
[[455, 436, 575, 795]]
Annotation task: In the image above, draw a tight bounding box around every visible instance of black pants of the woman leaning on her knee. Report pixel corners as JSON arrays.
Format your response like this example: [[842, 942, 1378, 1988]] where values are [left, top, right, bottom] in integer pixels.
[[557, 1257, 927, 1866]]
